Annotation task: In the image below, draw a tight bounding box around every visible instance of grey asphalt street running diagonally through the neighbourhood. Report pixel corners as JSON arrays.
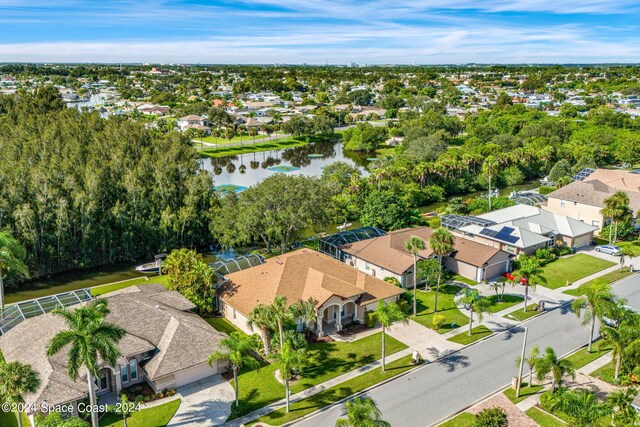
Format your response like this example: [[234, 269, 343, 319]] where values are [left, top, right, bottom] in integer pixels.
[[296, 274, 640, 427]]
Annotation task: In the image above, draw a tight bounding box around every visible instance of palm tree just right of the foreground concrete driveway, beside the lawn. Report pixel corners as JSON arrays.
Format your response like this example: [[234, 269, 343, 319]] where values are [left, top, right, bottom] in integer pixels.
[[209, 332, 260, 408]]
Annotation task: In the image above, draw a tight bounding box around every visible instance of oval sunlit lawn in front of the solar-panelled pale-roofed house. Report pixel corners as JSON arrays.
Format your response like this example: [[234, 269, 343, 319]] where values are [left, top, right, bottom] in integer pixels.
[[542, 254, 615, 289]]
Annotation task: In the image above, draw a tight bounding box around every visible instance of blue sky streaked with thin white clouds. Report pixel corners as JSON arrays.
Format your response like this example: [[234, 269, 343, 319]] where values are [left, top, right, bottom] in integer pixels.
[[0, 0, 640, 64]]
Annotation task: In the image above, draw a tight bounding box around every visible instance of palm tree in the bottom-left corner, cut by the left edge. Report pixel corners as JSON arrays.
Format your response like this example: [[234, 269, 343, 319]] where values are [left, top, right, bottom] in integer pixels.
[[0, 362, 40, 427]]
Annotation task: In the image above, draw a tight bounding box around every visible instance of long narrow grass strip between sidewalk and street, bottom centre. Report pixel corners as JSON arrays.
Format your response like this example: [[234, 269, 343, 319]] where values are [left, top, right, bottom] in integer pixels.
[[250, 356, 413, 425]]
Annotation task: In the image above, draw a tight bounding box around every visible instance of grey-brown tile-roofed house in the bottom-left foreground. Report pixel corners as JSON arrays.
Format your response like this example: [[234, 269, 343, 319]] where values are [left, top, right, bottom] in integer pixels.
[[0, 284, 226, 418]]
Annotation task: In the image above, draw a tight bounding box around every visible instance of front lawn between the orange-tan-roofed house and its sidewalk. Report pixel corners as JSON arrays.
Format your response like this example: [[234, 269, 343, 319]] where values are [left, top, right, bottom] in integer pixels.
[[230, 333, 407, 419]]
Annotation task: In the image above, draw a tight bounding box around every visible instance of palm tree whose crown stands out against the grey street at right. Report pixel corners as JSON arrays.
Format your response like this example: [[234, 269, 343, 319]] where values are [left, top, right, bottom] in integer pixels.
[[571, 279, 615, 353]]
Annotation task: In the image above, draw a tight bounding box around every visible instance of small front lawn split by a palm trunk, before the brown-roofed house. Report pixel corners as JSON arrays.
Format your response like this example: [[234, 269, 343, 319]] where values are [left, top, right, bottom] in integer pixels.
[[412, 285, 469, 334]]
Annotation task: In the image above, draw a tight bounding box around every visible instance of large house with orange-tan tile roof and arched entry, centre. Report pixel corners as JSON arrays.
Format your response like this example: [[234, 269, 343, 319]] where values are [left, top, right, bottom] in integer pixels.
[[218, 249, 403, 335]]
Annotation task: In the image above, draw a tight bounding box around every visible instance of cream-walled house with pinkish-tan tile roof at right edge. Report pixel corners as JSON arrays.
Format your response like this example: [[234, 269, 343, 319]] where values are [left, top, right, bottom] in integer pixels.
[[545, 173, 640, 229]]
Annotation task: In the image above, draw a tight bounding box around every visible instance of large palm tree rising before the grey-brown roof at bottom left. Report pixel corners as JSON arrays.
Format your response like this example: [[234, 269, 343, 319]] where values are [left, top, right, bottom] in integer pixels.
[[47, 299, 126, 427]]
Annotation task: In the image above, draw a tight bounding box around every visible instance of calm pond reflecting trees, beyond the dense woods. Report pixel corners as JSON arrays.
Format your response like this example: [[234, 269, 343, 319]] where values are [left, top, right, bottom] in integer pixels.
[[203, 142, 369, 191]]
